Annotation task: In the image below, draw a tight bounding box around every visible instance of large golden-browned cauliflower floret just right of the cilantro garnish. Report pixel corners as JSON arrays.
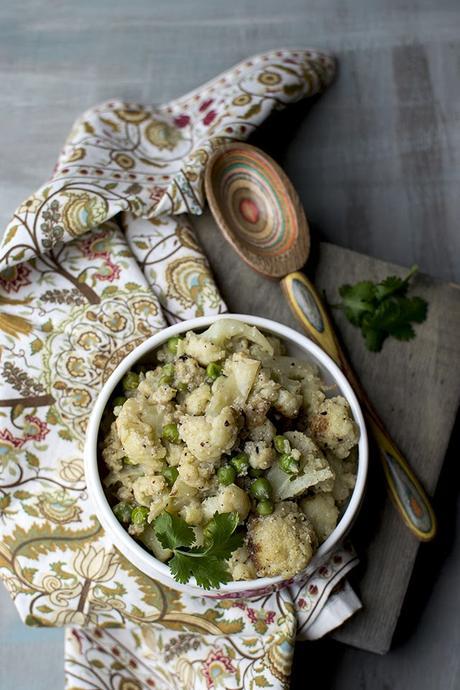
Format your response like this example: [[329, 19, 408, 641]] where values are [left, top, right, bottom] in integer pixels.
[[248, 501, 316, 577]]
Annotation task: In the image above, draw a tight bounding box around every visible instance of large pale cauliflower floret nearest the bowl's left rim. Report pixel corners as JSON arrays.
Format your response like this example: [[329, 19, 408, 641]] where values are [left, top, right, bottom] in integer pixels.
[[116, 398, 166, 470]]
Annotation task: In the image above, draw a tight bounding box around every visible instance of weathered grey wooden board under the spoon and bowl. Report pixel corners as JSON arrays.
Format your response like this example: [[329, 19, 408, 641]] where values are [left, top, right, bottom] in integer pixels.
[[195, 215, 460, 653]]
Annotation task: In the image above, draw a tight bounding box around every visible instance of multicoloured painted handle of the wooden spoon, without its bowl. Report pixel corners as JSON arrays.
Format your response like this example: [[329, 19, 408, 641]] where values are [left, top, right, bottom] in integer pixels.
[[281, 272, 436, 541]]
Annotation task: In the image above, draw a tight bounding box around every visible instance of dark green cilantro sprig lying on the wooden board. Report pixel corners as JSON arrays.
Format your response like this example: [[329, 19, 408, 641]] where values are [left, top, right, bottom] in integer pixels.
[[335, 266, 428, 352]]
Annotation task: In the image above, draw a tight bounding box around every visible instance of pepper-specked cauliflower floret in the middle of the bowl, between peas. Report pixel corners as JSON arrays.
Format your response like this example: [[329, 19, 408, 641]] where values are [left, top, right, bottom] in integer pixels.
[[179, 407, 238, 462]]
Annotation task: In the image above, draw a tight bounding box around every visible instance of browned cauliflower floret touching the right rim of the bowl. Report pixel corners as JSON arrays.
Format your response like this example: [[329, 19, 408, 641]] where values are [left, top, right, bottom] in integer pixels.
[[310, 395, 359, 459]]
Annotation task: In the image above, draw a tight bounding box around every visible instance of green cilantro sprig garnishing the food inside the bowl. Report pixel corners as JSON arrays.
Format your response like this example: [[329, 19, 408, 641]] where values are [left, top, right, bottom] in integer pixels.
[[154, 511, 243, 589]]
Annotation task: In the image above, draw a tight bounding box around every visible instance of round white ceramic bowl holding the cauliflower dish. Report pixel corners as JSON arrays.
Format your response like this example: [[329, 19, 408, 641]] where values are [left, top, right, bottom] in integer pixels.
[[85, 314, 368, 598]]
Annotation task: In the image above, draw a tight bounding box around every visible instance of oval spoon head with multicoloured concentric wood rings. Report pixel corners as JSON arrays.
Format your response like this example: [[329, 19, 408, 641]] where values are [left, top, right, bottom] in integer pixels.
[[205, 143, 310, 278]]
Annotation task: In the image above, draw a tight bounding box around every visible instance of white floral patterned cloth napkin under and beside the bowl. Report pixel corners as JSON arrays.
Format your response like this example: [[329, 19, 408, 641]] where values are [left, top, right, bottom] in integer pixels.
[[0, 50, 360, 690]]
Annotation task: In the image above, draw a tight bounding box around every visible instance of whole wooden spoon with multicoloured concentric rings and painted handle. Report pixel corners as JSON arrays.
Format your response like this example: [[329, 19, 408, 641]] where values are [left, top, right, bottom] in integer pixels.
[[205, 143, 436, 541]]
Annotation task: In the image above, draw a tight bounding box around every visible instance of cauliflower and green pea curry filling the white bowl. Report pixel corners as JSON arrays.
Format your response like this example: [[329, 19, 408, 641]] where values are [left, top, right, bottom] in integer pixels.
[[100, 319, 359, 580]]
